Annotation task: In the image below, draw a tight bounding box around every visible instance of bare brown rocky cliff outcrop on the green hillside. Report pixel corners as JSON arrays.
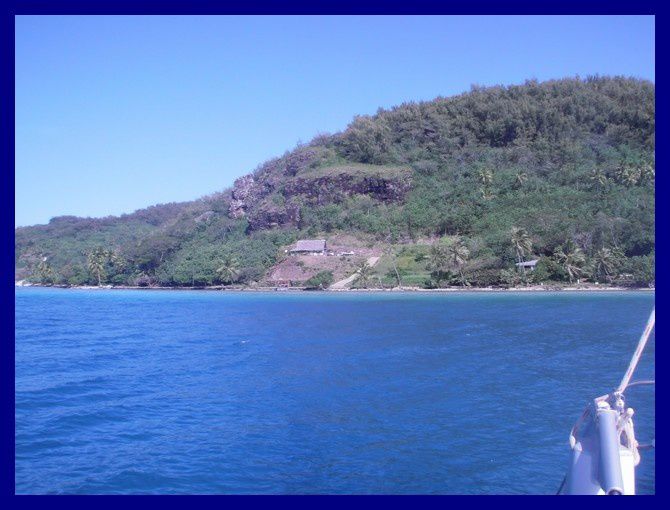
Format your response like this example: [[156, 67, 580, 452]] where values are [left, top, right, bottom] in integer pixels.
[[228, 147, 411, 230]]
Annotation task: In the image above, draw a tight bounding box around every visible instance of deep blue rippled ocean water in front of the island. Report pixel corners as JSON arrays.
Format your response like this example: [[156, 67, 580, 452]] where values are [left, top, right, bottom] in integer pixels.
[[15, 288, 655, 494]]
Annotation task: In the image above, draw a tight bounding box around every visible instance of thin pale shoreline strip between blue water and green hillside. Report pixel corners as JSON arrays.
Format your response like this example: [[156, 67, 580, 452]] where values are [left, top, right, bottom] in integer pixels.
[[14, 283, 656, 294]]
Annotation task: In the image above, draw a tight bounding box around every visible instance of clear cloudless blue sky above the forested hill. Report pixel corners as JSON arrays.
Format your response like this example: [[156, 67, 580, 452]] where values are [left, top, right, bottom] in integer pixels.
[[16, 16, 654, 225]]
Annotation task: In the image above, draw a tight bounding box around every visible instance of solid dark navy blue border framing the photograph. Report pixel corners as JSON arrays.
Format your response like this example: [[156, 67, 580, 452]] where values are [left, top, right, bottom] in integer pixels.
[[0, 0, 670, 508]]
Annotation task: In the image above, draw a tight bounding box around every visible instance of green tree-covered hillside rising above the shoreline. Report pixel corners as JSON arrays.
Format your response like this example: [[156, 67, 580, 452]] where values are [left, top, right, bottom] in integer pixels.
[[15, 77, 655, 287]]
